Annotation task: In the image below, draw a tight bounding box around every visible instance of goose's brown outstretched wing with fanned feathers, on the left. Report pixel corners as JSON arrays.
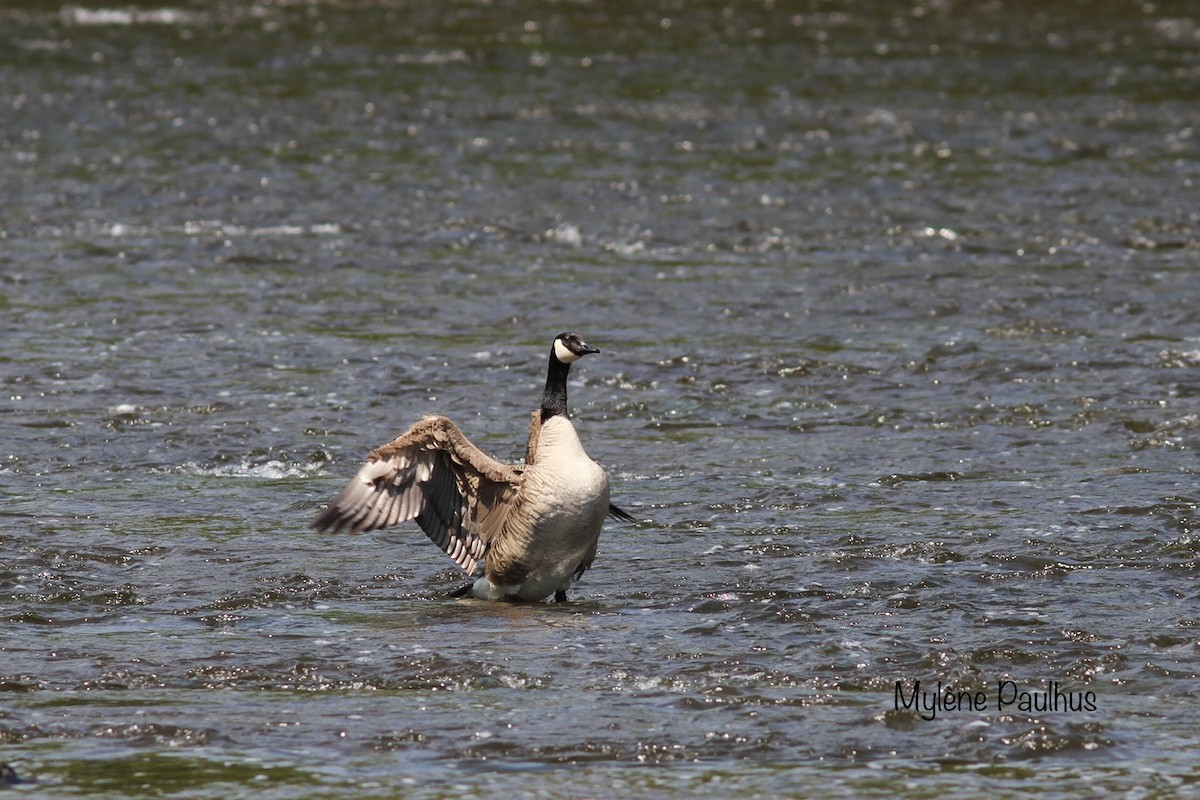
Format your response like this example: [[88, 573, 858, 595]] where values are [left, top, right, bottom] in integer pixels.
[[311, 416, 521, 572]]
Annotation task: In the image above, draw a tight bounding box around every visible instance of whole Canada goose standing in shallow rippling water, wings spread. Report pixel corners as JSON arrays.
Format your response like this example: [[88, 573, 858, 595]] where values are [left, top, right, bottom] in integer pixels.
[[311, 332, 634, 602]]
